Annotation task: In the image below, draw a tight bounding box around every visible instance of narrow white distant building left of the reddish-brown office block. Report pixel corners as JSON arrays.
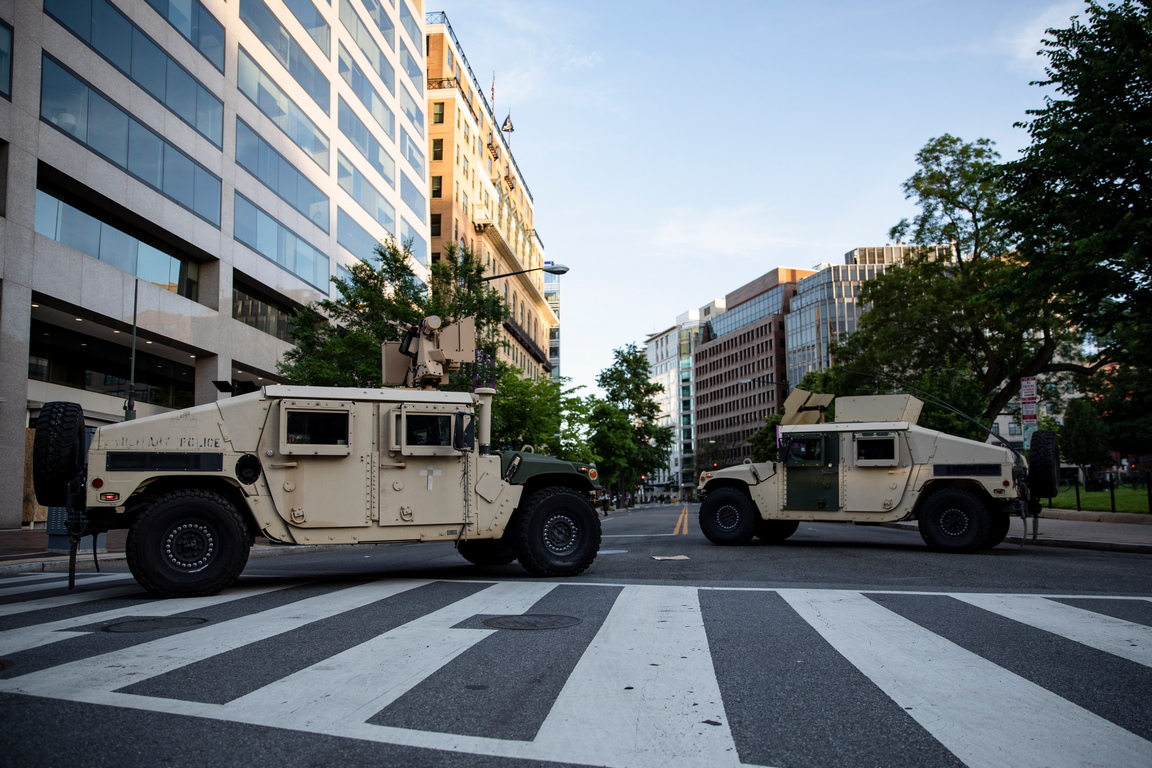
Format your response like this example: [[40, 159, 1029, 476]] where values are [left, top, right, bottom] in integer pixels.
[[644, 299, 725, 500]]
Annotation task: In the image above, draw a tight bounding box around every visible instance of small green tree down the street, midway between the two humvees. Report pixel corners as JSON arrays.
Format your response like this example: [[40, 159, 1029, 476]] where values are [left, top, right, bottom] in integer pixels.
[[589, 344, 673, 486]]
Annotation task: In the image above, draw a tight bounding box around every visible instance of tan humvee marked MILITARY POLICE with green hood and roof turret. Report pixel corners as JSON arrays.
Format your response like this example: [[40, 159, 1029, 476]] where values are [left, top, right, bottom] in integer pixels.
[[33, 317, 600, 596]]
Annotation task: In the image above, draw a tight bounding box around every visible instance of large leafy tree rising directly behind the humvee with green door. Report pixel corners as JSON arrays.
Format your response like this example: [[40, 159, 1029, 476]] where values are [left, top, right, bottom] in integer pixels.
[[831, 135, 1102, 436]]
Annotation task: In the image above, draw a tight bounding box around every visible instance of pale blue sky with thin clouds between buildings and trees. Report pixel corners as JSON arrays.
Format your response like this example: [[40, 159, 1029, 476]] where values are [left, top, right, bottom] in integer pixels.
[[427, 0, 1084, 390]]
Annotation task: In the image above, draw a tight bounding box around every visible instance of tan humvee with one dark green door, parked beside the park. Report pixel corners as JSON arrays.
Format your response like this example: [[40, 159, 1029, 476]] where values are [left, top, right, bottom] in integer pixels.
[[698, 389, 1060, 552]]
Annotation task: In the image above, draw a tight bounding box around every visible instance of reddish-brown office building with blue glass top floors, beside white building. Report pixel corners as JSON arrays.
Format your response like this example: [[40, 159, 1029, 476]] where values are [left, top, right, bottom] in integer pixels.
[[694, 267, 813, 469]]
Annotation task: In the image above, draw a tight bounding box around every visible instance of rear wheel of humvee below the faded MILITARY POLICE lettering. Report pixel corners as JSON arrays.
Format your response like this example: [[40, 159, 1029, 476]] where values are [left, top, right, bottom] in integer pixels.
[[126, 488, 251, 598]]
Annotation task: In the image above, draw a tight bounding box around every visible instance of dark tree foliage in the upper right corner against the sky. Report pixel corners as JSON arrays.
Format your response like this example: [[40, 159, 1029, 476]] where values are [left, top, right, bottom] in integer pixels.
[[1001, 0, 1152, 368]]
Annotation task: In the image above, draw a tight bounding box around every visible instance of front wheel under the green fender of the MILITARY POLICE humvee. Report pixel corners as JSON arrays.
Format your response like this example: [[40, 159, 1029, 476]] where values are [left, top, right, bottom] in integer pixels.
[[511, 486, 600, 576]]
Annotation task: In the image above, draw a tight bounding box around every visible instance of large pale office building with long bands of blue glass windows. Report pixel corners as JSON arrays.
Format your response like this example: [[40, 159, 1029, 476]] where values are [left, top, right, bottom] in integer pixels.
[[0, 0, 430, 527]]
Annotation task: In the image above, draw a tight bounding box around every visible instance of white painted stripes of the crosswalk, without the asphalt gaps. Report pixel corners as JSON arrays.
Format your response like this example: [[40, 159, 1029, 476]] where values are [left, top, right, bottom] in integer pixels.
[[0, 579, 1152, 768]]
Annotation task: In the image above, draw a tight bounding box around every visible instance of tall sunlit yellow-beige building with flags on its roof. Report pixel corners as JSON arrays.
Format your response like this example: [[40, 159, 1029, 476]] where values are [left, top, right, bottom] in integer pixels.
[[426, 13, 560, 379]]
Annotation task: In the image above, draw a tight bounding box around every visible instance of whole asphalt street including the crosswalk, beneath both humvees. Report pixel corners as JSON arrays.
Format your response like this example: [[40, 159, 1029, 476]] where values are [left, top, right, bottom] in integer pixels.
[[0, 504, 1152, 768]]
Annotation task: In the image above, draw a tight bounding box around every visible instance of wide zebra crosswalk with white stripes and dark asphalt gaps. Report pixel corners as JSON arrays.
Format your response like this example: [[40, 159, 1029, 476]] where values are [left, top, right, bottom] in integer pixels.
[[0, 573, 1152, 768]]
